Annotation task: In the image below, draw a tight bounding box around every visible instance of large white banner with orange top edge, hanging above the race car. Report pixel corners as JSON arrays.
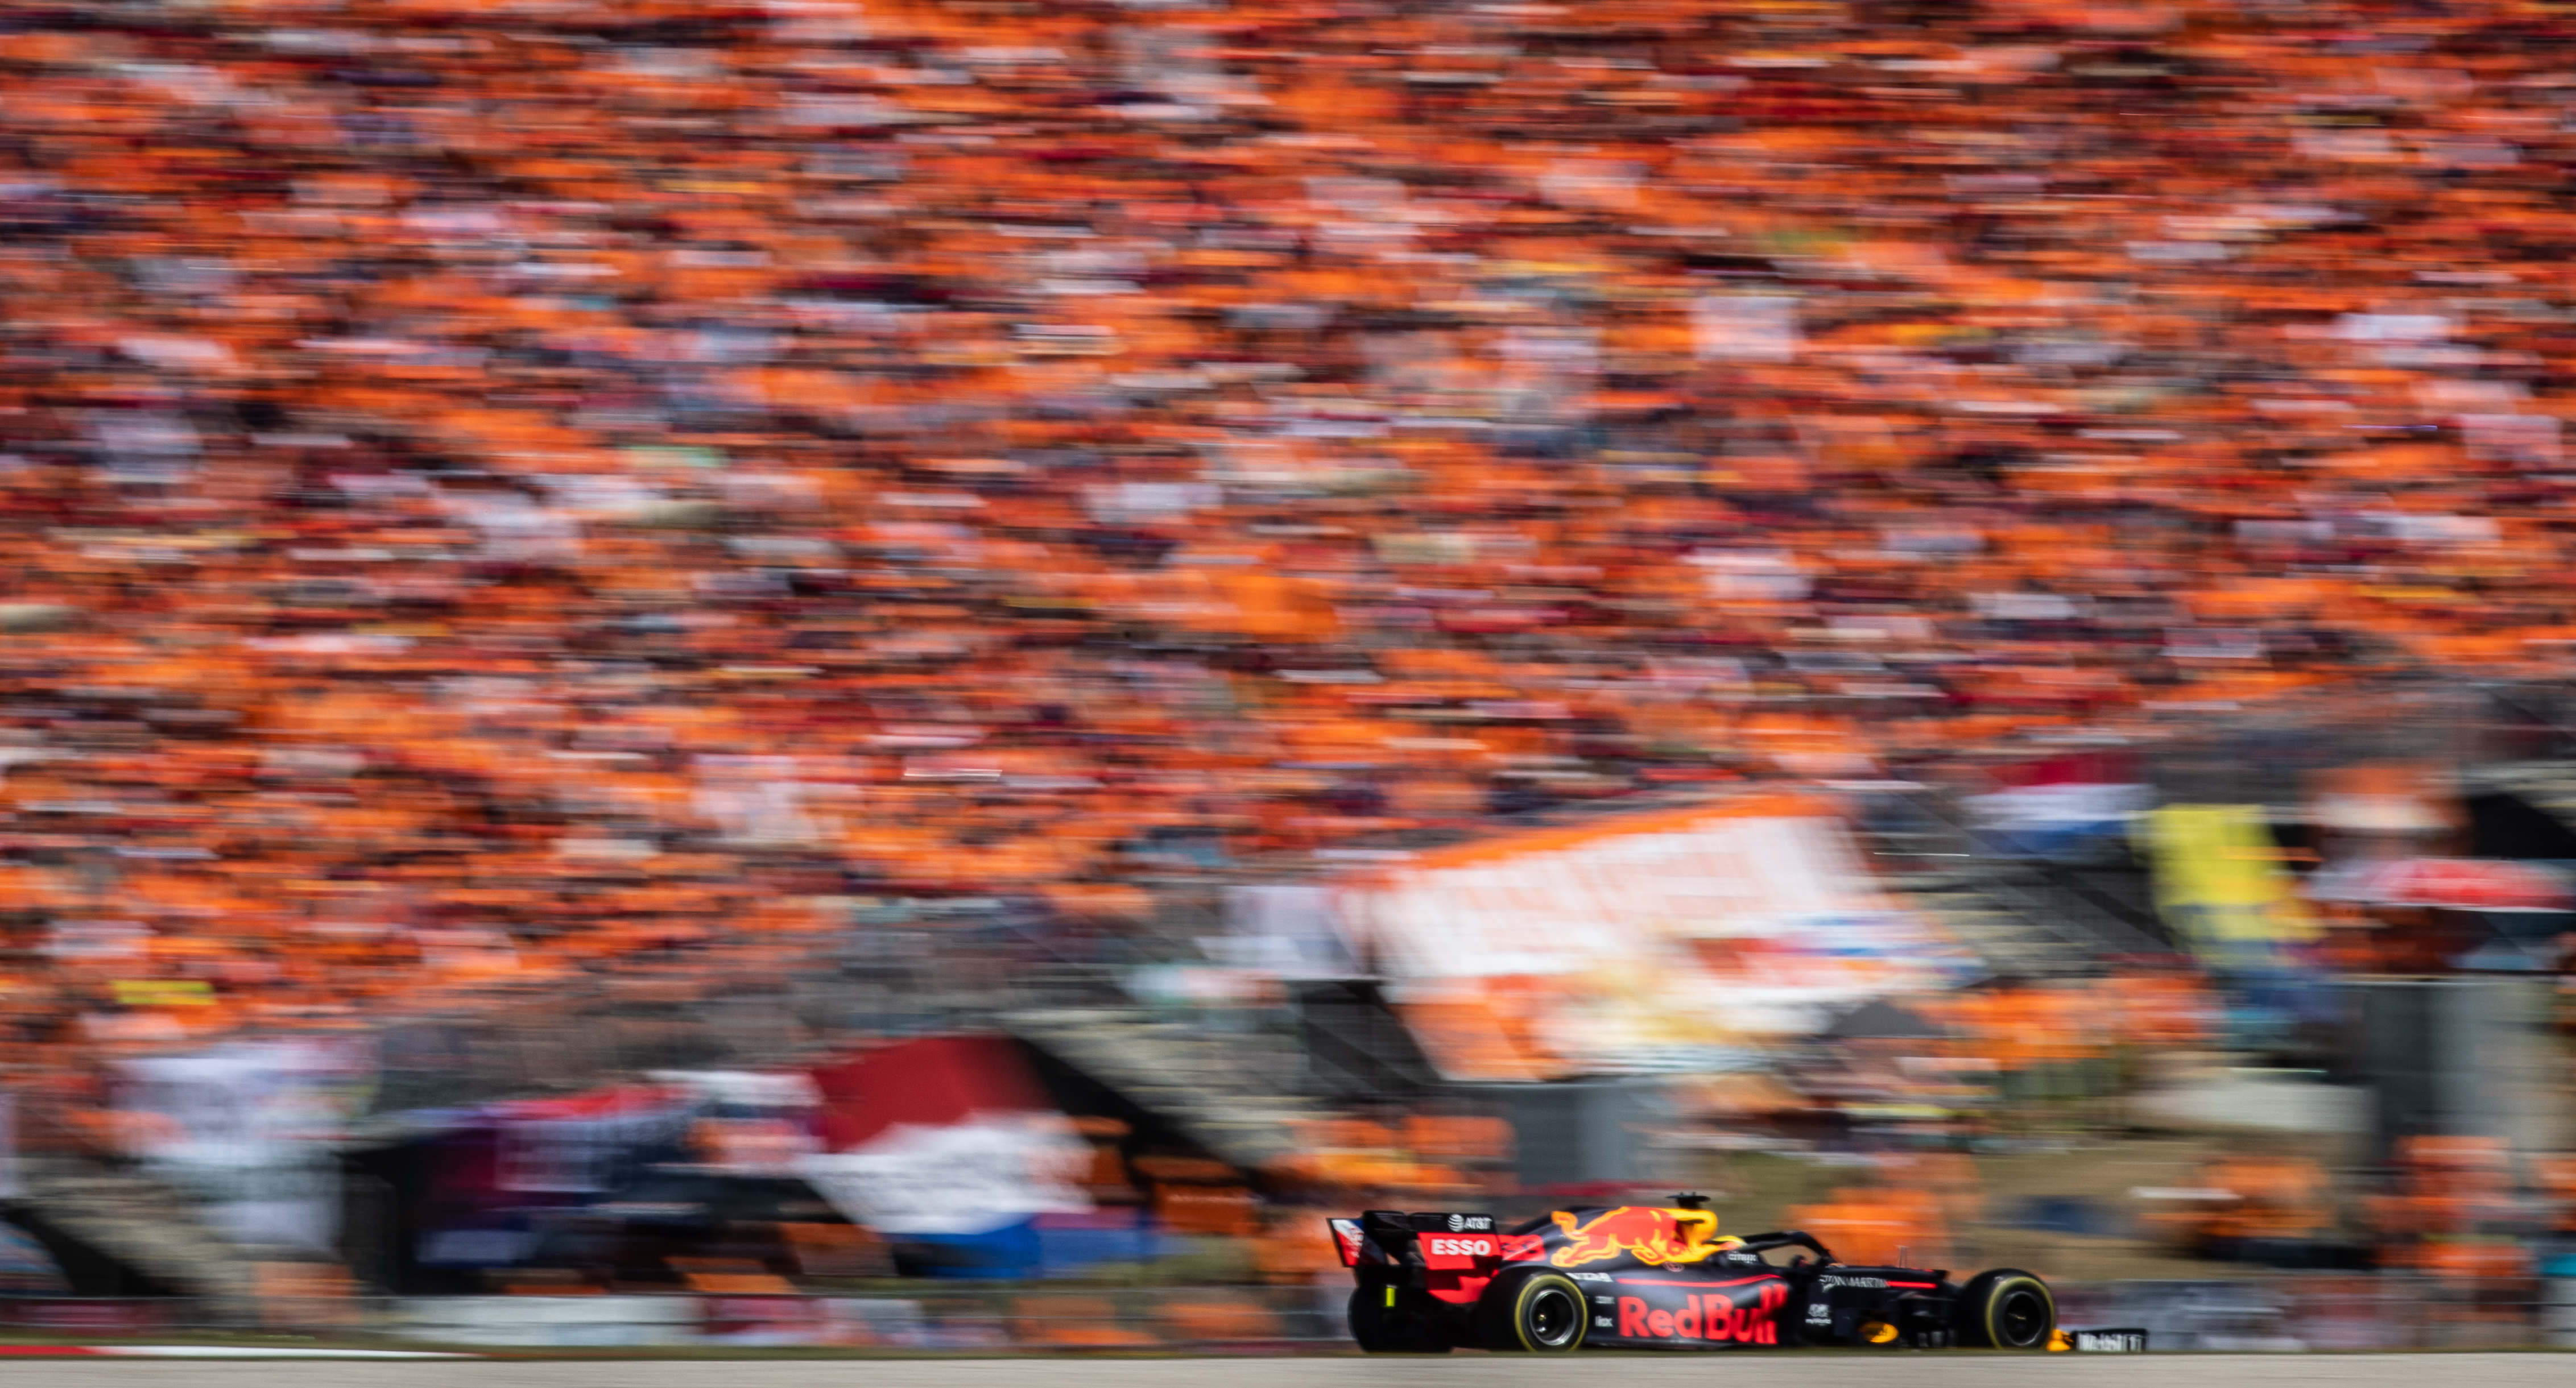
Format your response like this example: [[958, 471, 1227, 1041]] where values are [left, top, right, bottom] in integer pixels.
[[1337, 795, 1971, 1079]]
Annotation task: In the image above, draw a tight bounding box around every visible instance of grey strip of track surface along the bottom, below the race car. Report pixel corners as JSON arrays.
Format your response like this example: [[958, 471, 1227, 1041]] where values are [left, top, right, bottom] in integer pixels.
[[0, 1354, 2576, 1388]]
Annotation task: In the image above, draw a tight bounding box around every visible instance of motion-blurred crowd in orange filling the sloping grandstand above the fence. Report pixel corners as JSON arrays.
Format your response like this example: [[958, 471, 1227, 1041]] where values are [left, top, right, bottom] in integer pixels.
[[0, 0, 2576, 1107]]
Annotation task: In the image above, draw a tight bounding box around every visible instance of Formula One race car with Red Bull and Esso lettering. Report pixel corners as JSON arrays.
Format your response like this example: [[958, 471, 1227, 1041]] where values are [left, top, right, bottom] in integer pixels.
[[1329, 1195, 2091, 1354]]
